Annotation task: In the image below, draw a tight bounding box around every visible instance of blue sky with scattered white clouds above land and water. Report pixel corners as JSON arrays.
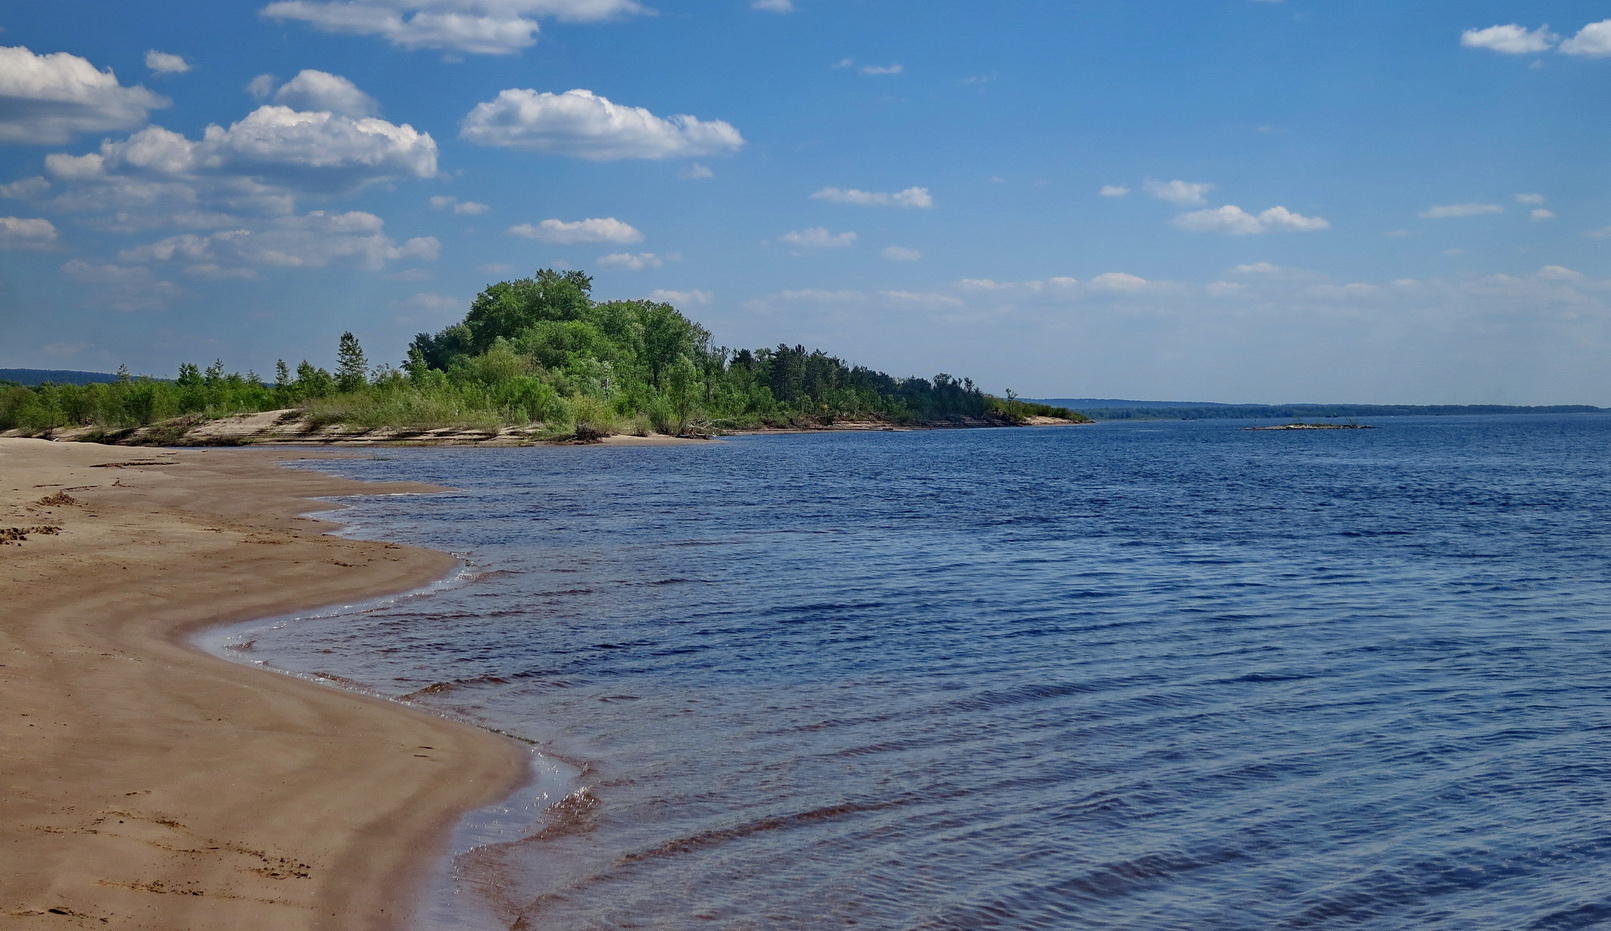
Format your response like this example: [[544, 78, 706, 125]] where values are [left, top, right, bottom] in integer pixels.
[[0, 0, 1611, 406]]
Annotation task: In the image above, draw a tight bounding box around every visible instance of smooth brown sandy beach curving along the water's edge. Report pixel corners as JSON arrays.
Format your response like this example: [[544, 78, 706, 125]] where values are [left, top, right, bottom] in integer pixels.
[[0, 440, 527, 931]]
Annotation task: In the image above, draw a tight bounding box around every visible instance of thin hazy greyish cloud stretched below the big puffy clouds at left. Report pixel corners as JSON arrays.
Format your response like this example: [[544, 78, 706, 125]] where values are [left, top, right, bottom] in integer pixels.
[[118, 211, 441, 271]]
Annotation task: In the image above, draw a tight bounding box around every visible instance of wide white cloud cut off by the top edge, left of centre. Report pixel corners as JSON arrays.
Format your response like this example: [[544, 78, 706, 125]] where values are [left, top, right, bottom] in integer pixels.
[[261, 0, 649, 55]]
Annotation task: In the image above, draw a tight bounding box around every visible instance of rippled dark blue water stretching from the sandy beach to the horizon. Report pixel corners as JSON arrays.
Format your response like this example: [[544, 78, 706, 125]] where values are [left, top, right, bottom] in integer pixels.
[[207, 416, 1611, 931]]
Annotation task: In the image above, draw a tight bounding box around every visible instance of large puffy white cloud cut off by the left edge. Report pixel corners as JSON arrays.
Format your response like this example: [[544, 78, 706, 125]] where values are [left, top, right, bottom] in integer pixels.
[[0, 47, 169, 145]]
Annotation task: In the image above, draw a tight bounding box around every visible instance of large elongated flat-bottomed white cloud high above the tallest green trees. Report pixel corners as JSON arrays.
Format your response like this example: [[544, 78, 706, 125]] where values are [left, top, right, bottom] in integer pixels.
[[459, 89, 744, 161]]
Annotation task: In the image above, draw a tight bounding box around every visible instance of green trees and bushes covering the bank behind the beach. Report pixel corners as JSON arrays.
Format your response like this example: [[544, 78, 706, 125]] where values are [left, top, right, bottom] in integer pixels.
[[0, 269, 1083, 438]]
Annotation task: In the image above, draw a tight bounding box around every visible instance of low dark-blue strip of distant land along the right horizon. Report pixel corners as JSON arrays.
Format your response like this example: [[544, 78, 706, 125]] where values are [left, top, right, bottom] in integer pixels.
[[1026, 398, 1606, 420]]
